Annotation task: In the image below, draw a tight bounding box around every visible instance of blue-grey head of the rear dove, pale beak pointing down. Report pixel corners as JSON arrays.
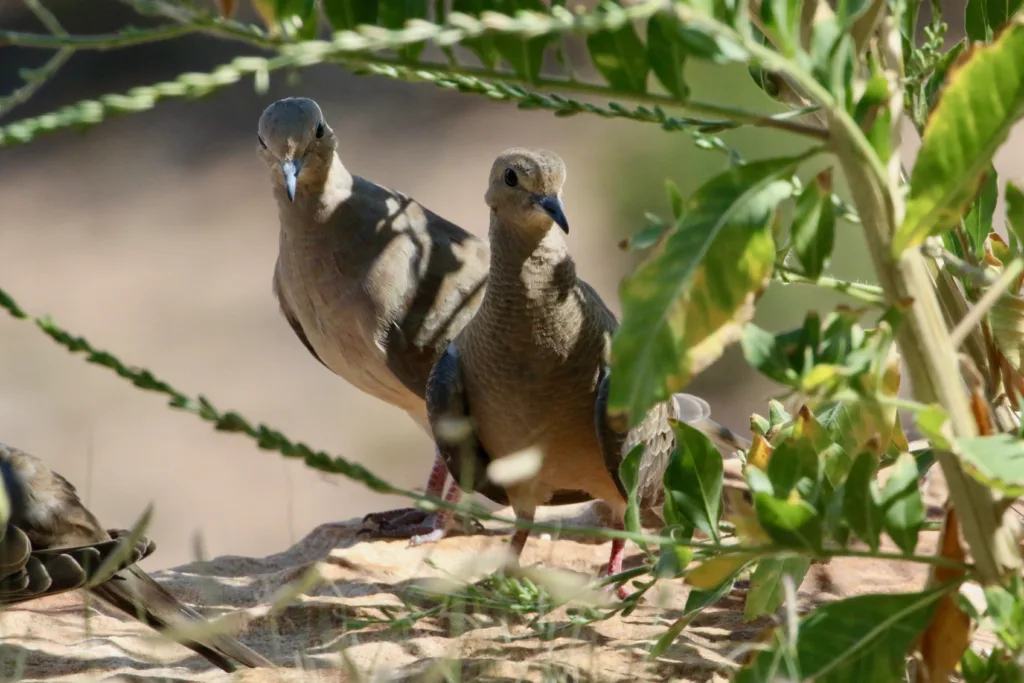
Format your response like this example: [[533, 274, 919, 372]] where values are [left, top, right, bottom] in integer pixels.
[[258, 97, 335, 202]]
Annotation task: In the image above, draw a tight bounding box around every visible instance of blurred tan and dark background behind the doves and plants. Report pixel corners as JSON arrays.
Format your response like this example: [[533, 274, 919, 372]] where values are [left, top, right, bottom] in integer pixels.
[[0, 0, 1024, 567]]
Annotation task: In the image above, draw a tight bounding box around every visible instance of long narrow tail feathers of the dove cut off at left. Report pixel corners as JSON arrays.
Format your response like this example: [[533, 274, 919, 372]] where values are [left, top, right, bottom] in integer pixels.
[[89, 566, 273, 673]]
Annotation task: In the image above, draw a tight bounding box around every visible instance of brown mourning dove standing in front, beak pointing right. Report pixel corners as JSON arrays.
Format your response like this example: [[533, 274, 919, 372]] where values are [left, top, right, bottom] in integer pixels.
[[423, 148, 745, 593]]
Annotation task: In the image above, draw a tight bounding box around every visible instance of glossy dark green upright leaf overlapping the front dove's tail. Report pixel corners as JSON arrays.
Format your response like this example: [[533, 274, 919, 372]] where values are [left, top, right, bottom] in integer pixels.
[[665, 422, 722, 543]]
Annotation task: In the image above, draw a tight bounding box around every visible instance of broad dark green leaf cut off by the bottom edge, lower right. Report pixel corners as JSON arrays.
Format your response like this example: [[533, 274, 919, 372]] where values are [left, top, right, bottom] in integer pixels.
[[735, 587, 947, 683]]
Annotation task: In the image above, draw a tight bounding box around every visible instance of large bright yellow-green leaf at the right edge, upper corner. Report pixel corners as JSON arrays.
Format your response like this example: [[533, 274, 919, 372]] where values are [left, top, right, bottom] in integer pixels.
[[893, 20, 1024, 254]]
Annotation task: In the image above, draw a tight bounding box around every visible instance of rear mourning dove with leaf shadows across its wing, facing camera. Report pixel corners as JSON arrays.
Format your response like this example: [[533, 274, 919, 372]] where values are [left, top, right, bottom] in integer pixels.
[[258, 97, 587, 537]]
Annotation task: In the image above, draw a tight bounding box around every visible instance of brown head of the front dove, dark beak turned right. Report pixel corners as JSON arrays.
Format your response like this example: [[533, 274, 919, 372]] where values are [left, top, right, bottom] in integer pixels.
[[484, 147, 569, 234]]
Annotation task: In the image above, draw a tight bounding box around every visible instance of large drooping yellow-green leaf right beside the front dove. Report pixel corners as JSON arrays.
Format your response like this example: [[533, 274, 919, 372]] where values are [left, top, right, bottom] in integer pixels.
[[608, 159, 799, 424]]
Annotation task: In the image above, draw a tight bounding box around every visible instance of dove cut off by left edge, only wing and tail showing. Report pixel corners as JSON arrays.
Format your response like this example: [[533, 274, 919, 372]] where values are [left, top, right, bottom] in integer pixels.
[[0, 443, 273, 672]]
